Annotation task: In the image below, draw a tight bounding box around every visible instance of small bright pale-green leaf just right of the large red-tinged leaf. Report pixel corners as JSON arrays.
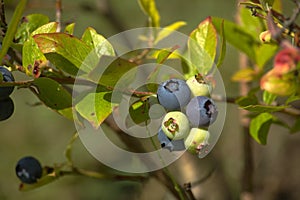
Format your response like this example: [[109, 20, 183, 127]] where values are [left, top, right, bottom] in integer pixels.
[[81, 27, 115, 58]]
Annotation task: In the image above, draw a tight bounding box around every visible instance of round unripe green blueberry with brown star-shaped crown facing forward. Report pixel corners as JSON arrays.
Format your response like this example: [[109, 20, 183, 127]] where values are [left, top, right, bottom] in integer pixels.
[[161, 111, 190, 140]]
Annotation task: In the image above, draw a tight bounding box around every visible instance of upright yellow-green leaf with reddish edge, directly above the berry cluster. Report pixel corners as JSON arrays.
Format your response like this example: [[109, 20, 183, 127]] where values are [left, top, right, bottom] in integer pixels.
[[188, 17, 217, 74]]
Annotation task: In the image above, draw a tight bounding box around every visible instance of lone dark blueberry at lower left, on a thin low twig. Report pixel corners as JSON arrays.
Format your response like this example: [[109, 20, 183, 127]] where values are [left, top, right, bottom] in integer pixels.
[[16, 156, 43, 184]]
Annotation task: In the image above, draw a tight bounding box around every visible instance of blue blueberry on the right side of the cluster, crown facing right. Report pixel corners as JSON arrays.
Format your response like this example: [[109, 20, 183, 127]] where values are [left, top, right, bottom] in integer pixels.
[[186, 96, 218, 127]]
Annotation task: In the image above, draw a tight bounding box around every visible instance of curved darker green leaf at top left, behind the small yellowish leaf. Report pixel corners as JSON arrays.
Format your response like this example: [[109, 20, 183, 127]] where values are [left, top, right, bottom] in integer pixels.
[[15, 14, 49, 44]]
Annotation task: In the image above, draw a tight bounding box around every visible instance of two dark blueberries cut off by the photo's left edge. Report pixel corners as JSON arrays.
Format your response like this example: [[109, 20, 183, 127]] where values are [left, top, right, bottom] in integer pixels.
[[0, 66, 15, 121]]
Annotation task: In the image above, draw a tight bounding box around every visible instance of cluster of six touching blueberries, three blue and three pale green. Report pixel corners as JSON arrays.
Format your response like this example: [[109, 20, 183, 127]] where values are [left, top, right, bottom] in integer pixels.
[[157, 74, 218, 154]]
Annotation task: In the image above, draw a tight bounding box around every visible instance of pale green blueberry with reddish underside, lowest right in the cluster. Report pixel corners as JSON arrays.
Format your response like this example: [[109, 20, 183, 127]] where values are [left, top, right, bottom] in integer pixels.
[[184, 128, 209, 154]]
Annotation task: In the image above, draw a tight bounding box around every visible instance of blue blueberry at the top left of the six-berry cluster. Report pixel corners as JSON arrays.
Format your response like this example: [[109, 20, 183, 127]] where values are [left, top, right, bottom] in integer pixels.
[[157, 79, 191, 111]]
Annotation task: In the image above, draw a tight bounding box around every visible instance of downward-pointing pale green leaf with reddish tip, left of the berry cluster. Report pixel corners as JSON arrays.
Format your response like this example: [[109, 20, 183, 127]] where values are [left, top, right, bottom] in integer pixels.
[[75, 90, 117, 129]]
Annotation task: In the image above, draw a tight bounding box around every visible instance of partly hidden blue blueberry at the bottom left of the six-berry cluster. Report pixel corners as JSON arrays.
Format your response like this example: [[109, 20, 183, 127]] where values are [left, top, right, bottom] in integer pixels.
[[157, 128, 185, 151]]
